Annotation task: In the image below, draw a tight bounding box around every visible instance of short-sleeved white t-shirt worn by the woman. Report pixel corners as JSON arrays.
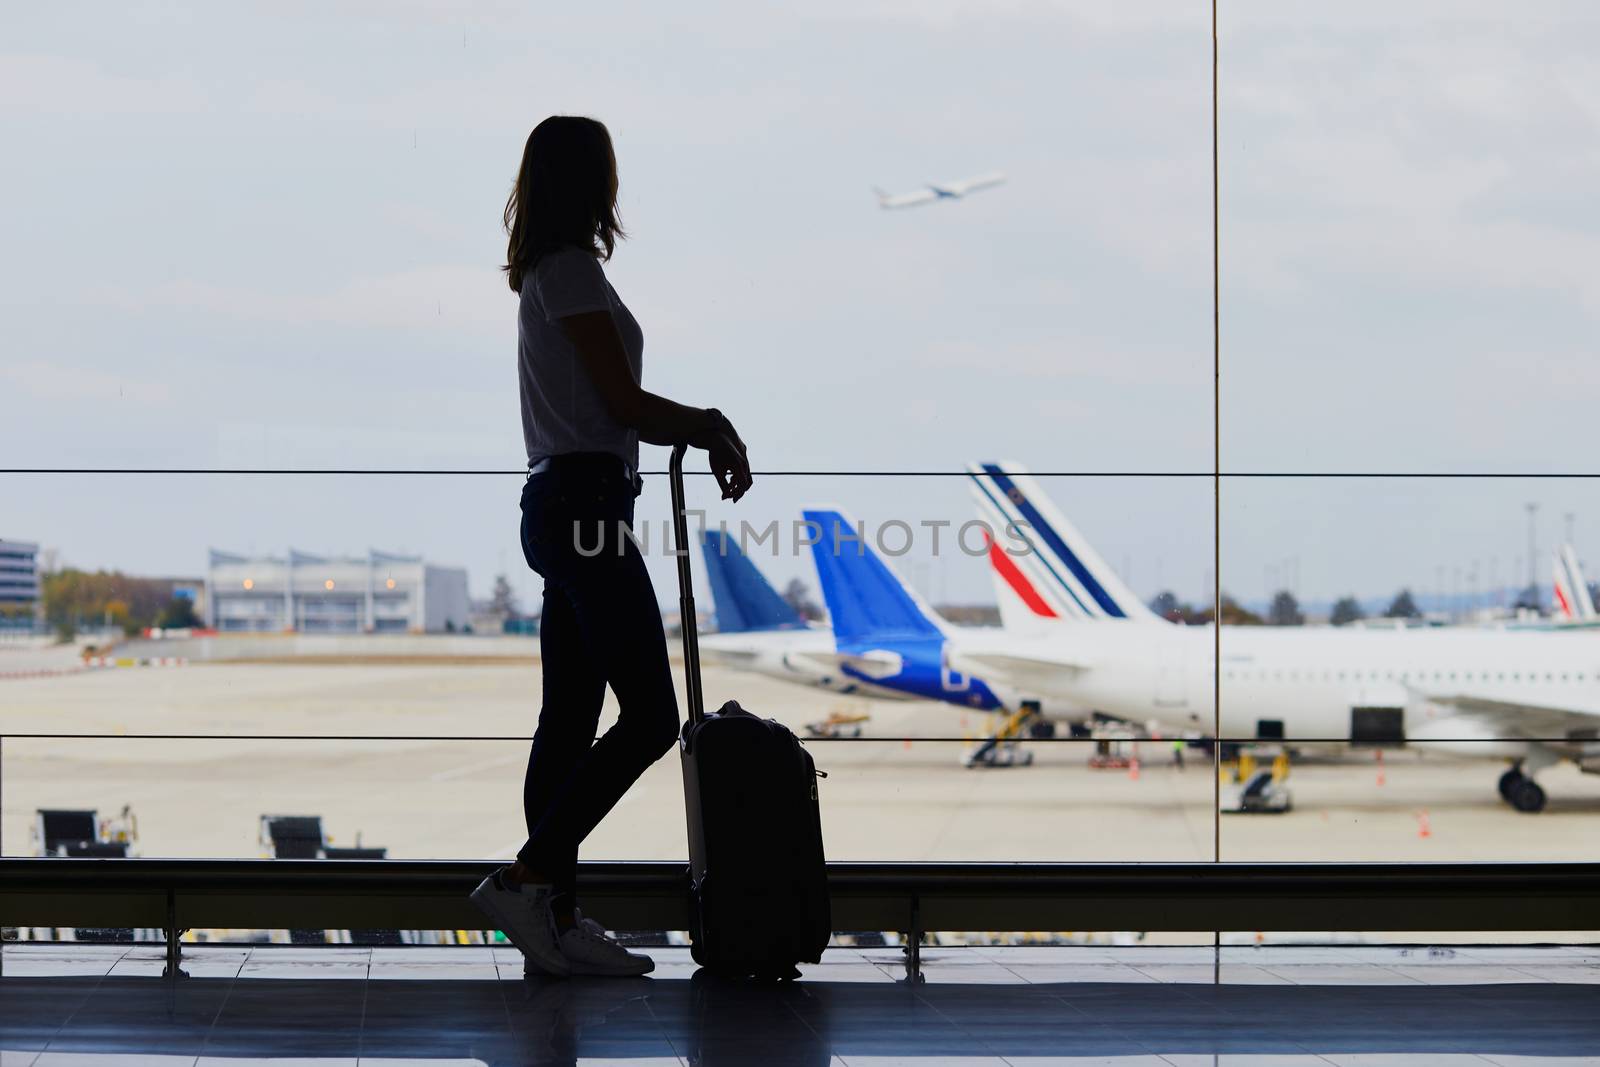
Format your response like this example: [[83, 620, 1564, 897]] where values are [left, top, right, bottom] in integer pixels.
[[517, 248, 645, 470]]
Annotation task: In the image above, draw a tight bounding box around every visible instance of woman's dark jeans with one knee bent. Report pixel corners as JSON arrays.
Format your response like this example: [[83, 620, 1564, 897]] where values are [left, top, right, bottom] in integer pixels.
[[517, 453, 678, 894]]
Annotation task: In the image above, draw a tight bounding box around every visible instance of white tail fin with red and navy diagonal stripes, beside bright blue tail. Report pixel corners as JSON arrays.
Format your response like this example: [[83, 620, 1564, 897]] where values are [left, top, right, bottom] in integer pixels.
[[968, 462, 1160, 624]]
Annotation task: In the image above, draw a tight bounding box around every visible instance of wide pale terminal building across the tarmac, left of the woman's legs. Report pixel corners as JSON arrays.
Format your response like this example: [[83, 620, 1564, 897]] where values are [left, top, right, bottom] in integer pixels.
[[205, 549, 470, 633]]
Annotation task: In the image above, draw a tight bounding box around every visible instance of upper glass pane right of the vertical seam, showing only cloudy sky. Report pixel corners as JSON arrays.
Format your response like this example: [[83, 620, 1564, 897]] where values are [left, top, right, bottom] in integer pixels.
[[1218, 0, 1600, 472]]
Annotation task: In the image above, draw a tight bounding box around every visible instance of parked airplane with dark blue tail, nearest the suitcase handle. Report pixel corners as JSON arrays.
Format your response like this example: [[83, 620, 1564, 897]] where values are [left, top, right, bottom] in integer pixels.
[[699, 530, 906, 699]]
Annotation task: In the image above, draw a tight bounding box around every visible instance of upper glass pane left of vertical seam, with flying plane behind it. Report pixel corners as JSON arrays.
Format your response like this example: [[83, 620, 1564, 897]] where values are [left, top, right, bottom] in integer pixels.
[[0, 3, 1210, 470]]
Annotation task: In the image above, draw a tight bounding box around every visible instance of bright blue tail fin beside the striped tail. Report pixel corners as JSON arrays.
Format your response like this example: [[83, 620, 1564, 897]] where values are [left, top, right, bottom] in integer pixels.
[[805, 509, 944, 646]]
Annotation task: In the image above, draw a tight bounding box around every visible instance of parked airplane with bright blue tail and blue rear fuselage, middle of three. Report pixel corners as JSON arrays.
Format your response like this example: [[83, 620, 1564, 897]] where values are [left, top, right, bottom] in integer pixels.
[[803, 509, 1107, 721]]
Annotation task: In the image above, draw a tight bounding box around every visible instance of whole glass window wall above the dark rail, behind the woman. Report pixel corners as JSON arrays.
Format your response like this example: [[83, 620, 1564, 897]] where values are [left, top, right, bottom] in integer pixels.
[[0, 2, 1600, 927]]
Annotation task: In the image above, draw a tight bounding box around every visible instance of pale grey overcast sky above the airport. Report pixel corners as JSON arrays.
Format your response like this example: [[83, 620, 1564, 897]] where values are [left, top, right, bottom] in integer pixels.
[[0, 0, 1600, 600]]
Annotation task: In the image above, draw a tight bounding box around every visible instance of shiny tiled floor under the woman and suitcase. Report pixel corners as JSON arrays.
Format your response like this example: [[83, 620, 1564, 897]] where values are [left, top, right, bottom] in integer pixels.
[[0, 944, 1600, 1067]]
